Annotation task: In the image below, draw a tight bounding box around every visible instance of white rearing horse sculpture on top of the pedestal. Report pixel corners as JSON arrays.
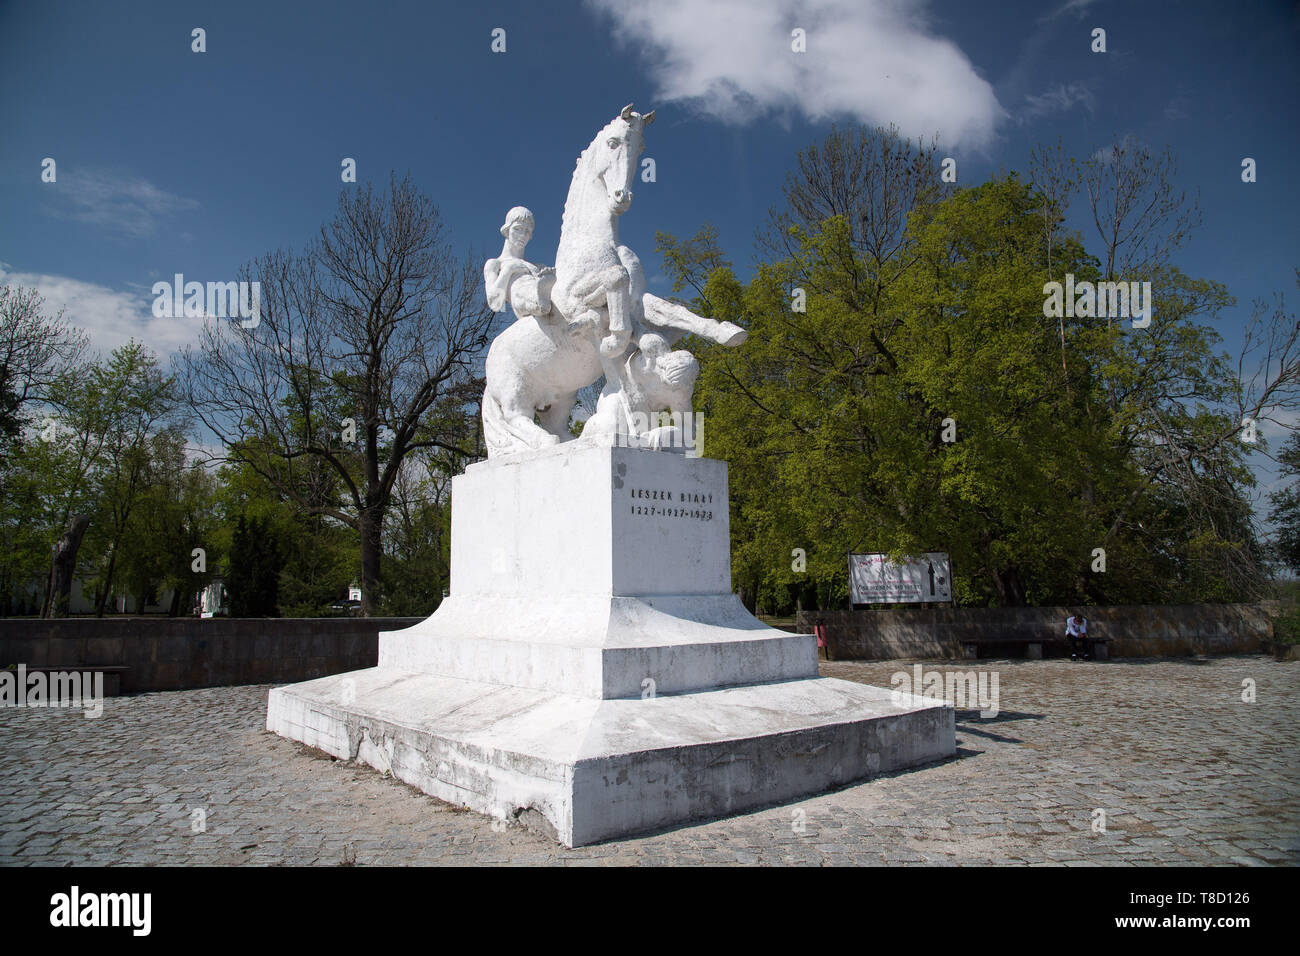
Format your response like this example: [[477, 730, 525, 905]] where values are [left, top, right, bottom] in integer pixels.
[[482, 103, 748, 457]]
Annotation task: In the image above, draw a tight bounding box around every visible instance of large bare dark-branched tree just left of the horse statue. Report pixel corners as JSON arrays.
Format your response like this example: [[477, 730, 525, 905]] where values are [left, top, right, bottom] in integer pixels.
[[182, 177, 493, 614]]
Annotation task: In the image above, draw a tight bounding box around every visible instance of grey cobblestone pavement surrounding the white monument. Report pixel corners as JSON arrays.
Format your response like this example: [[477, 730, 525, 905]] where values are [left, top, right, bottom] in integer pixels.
[[0, 657, 1300, 866]]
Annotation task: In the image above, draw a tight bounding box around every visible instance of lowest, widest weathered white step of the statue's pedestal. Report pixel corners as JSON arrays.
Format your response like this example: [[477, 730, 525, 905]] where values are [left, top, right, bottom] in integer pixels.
[[267, 667, 954, 847]]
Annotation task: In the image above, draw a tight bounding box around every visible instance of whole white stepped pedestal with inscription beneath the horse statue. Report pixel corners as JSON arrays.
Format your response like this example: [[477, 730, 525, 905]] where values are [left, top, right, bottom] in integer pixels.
[[267, 444, 956, 847]]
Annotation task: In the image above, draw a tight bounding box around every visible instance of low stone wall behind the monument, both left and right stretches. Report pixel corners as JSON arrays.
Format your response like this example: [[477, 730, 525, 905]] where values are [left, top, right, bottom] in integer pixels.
[[0, 605, 1273, 693]]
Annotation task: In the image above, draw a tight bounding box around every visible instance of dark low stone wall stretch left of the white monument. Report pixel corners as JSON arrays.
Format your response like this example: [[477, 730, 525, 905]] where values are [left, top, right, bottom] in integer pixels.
[[0, 618, 421, 693]]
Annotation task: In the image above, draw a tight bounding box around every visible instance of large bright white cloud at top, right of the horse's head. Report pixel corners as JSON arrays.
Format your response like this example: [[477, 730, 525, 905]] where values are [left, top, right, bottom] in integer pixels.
[[588, 0, 1005, 147]]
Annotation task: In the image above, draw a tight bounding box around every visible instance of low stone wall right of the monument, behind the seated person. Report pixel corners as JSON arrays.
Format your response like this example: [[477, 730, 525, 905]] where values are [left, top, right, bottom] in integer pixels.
[[798, 605, 1273, 661]]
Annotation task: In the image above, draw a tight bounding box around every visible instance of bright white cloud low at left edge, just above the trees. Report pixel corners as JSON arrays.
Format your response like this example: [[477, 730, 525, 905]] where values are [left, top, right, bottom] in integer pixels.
[[0, 263, 203, 363]]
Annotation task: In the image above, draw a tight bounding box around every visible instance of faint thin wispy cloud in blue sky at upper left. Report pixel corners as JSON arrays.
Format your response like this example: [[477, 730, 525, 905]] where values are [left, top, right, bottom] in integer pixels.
[[42, 168, 199, 238]]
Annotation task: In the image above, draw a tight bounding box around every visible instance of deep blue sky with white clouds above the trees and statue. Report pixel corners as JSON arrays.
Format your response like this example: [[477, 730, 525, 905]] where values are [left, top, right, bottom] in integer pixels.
[[0, 0, 1300, 486]]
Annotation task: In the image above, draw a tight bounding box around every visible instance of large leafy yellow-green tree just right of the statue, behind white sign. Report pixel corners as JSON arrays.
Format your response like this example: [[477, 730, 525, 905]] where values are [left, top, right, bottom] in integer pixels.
[[701, 178, 1096, 606]]
